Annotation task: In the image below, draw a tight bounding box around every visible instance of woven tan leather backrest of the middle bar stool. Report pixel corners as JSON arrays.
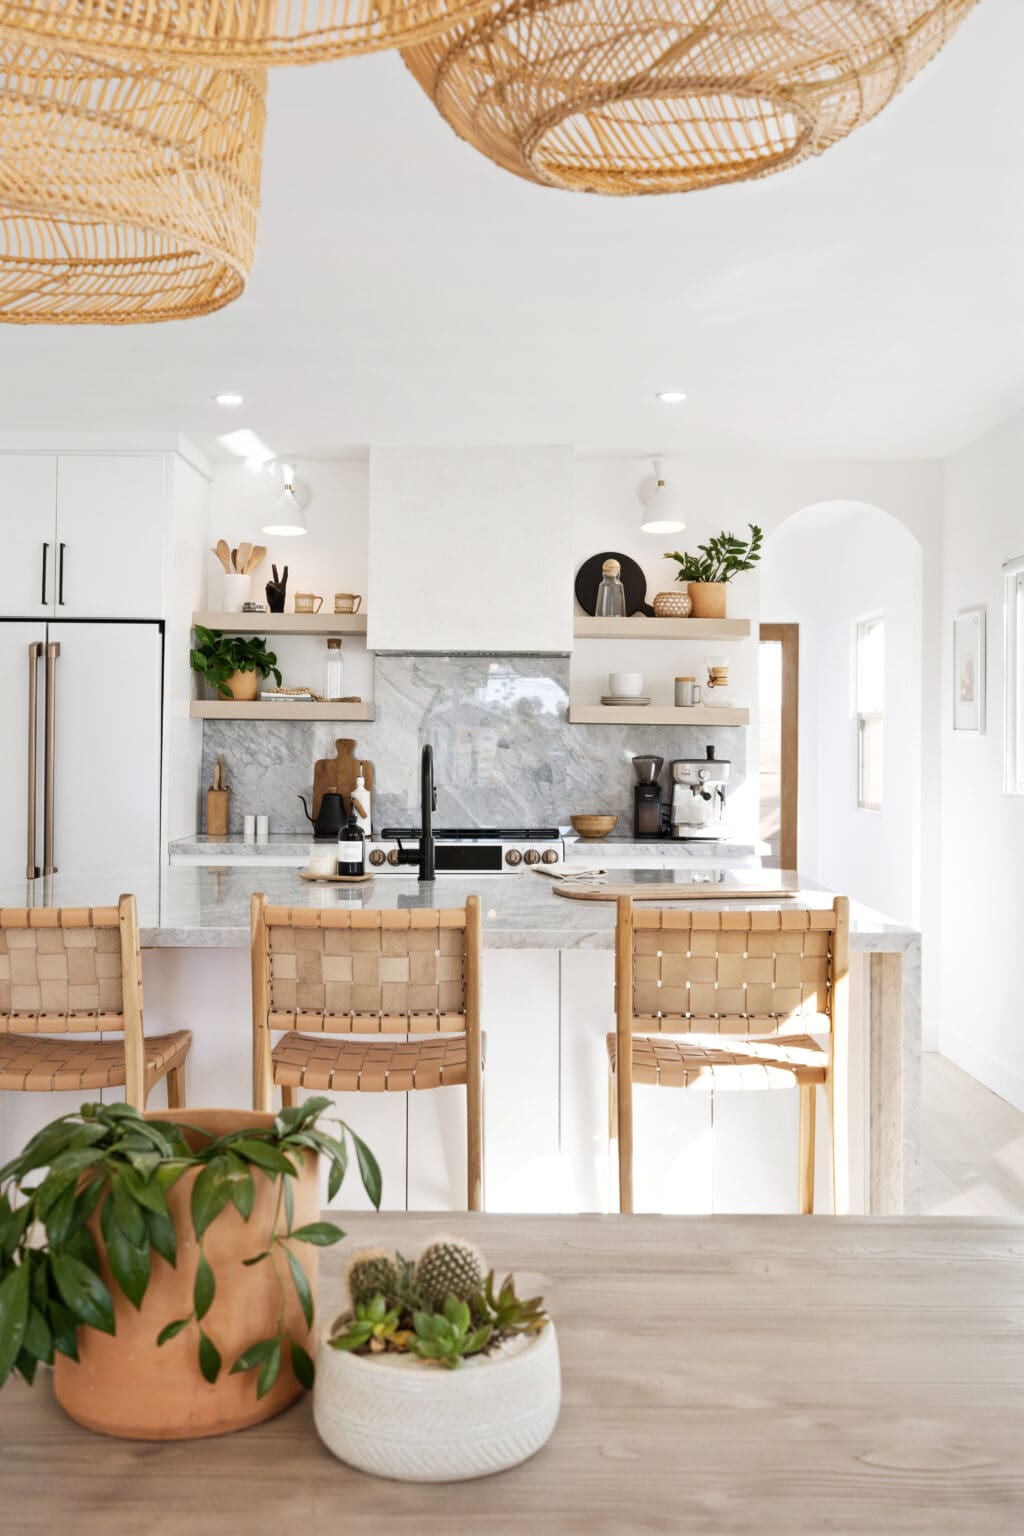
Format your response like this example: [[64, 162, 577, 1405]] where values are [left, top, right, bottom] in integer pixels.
[[266, 906, 465, 1035]]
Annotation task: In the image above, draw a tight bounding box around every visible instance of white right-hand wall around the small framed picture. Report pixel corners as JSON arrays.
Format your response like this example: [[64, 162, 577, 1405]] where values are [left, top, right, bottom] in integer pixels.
[[941, 413, 1024, 1109]]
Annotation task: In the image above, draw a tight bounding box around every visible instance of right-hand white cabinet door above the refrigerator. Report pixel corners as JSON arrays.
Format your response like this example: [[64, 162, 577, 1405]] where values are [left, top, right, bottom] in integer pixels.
[[57, 453, 167, 619]]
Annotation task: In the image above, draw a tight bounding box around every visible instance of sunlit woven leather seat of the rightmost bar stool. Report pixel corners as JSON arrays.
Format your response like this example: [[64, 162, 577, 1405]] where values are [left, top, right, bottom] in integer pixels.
[[608, 1035, 829, 1089]]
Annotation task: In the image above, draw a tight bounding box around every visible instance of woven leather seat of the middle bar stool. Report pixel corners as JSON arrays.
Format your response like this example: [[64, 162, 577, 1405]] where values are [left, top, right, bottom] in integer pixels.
[[272, 1032, 482, 1094]]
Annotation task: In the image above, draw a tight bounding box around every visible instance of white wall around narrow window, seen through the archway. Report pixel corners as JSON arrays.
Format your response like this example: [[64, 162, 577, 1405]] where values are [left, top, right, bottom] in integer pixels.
[[761, 502, 921, 926]]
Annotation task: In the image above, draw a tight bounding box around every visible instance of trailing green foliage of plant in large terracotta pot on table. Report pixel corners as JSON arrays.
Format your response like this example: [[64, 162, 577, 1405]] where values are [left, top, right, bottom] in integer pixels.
[[0, 1098, 381, 1398]]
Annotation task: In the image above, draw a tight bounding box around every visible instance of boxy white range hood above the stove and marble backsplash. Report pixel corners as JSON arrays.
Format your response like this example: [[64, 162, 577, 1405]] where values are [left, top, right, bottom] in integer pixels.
[[367, 447, 573, 653]]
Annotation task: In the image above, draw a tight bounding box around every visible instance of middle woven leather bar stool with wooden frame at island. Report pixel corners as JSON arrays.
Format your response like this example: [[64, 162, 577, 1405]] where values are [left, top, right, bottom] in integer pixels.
[[252, 895, 484, 1210]]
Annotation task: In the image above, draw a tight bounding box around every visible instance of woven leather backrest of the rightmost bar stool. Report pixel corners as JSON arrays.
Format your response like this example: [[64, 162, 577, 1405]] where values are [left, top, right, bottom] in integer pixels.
[[633, 908, 837, 1035]]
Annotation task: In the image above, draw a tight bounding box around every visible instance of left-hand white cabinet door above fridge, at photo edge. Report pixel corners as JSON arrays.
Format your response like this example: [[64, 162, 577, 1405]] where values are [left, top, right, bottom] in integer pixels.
[[0, 453, 57, 619]]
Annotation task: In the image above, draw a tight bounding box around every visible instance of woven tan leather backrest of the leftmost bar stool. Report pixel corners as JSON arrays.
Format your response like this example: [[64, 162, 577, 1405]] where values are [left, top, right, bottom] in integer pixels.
[[0, 906, 132, 1035]]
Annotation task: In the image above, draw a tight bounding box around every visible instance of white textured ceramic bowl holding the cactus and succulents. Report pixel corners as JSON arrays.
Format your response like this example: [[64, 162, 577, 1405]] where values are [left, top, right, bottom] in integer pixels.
[[313, 1322, 562, 1482]]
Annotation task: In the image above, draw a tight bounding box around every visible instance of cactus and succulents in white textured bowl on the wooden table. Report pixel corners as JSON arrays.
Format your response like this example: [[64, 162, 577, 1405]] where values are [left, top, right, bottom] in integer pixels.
[[313, 1236, 562, 1482]]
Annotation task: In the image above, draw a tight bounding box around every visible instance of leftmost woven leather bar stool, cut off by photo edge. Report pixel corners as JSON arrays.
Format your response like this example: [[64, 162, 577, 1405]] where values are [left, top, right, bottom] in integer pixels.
[[0, 895, 192, 1109]]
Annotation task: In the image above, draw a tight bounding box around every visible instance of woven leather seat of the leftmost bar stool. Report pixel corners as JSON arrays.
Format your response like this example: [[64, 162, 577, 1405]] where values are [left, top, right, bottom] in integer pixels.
[[0, 1029, 192, 1094]]
